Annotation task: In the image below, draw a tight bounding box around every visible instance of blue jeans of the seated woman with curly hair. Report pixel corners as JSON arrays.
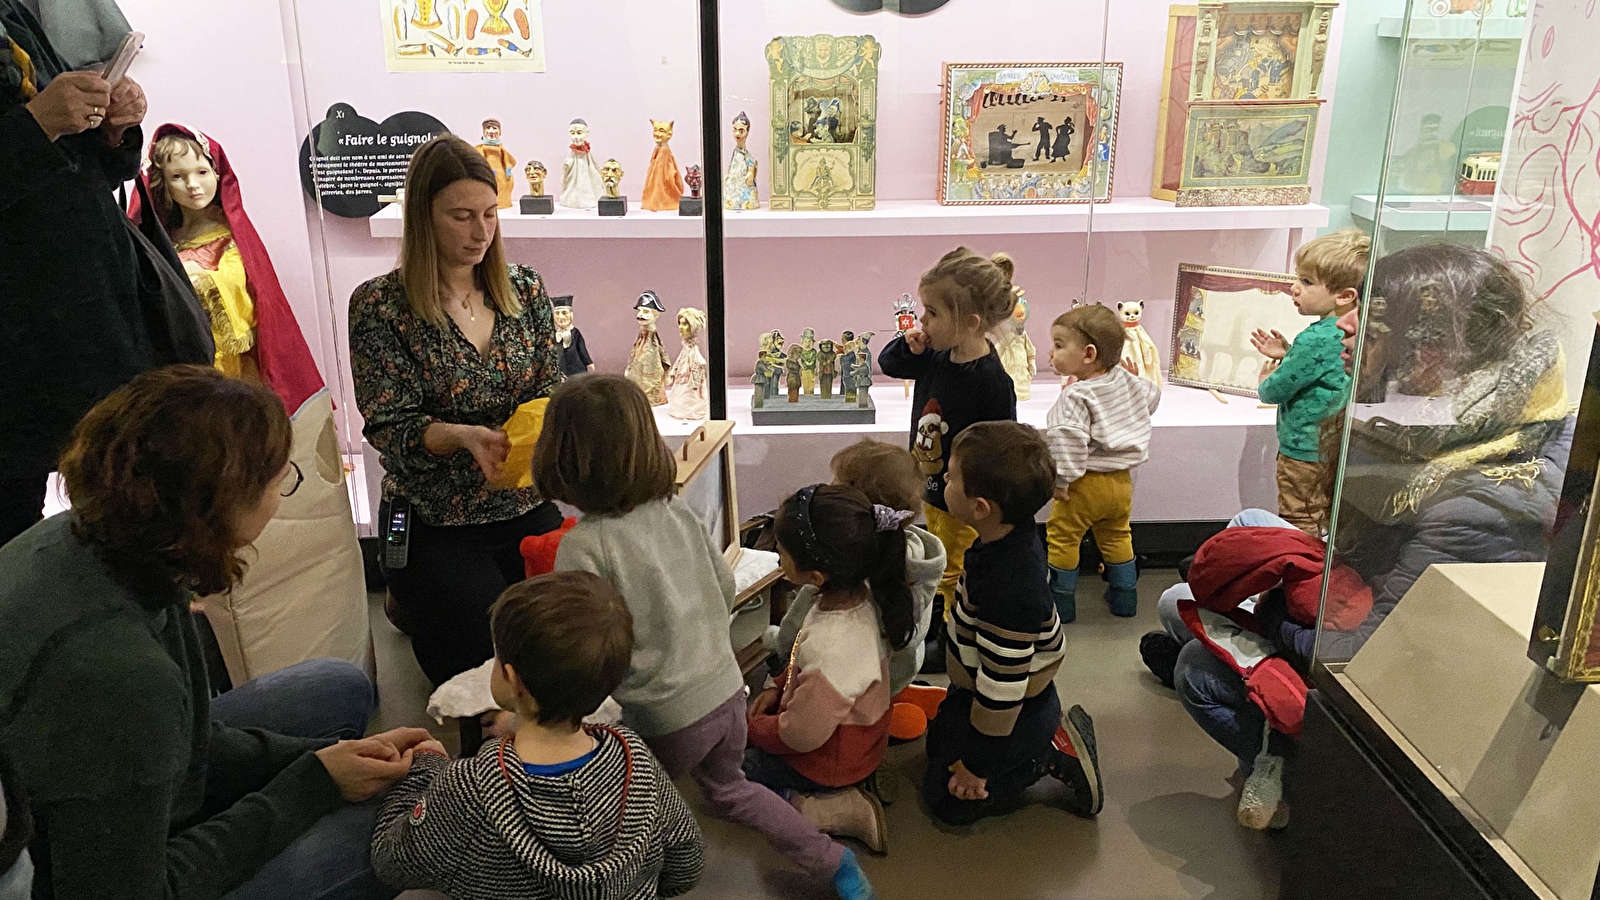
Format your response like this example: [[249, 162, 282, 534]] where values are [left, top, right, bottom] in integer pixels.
[[211, 660, 400, 900]]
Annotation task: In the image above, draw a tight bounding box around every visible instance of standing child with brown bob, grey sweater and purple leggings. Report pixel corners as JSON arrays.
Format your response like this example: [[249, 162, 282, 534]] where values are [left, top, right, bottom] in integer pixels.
[[533, 375, 874, 898]]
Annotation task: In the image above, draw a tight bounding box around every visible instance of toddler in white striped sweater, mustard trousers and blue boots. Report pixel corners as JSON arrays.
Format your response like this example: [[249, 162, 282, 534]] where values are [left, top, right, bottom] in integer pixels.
[[1045, 304, 1162, 621]]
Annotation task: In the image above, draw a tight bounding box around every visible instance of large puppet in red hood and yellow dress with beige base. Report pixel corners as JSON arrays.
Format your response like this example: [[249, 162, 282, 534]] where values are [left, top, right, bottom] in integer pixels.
[[128, 125, 371, 684]]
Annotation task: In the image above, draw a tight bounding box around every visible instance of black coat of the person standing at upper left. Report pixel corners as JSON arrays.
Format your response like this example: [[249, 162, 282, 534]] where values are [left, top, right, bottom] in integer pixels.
[[0, 0, 155, 477]]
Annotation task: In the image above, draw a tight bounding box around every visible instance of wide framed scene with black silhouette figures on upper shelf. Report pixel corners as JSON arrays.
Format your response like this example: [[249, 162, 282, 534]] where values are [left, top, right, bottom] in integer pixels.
[[939, 62, 1122, 205]]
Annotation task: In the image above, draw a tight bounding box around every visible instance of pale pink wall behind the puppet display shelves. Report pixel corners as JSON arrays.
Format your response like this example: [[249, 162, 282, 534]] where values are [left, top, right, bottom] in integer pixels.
[[109, 0, 1338, 428]]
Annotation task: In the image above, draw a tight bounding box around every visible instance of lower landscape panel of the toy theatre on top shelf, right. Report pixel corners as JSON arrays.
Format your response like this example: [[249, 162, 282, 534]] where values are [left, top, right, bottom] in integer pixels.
[[1178, 99, 1322, 207]]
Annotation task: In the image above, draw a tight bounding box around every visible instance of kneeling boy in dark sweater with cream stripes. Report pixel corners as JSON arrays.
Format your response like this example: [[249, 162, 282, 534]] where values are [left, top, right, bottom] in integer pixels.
[[923, 421, 1102, 825]]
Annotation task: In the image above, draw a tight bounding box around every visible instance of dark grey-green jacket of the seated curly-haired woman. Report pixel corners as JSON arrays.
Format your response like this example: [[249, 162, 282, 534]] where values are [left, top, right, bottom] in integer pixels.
[[0, 512, 342, 900]]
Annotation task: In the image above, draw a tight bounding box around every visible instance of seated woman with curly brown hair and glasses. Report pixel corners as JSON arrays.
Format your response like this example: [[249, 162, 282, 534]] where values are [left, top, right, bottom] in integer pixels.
[[0, 365, 427, 900]]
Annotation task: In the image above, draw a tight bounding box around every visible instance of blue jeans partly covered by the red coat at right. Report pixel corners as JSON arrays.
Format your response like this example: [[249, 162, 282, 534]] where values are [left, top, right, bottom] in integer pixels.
[[1155, 509, 1294, 775]]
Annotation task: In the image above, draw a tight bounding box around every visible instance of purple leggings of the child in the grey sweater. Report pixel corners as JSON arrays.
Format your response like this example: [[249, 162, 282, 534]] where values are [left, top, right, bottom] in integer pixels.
[[645, 692, 845, 879]]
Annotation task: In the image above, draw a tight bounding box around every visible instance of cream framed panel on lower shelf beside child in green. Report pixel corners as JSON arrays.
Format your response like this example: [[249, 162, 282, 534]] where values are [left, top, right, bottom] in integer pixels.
[[1170, 263, 1314, 397]]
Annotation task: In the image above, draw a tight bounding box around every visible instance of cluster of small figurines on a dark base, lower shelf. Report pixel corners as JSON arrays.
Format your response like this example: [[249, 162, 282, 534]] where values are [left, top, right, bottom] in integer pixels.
[[750, 328, 872, 408]]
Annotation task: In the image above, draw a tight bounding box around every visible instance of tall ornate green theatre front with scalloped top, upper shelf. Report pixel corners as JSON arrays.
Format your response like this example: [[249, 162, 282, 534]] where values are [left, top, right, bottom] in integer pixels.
[[766, 34, 883, 210]]
